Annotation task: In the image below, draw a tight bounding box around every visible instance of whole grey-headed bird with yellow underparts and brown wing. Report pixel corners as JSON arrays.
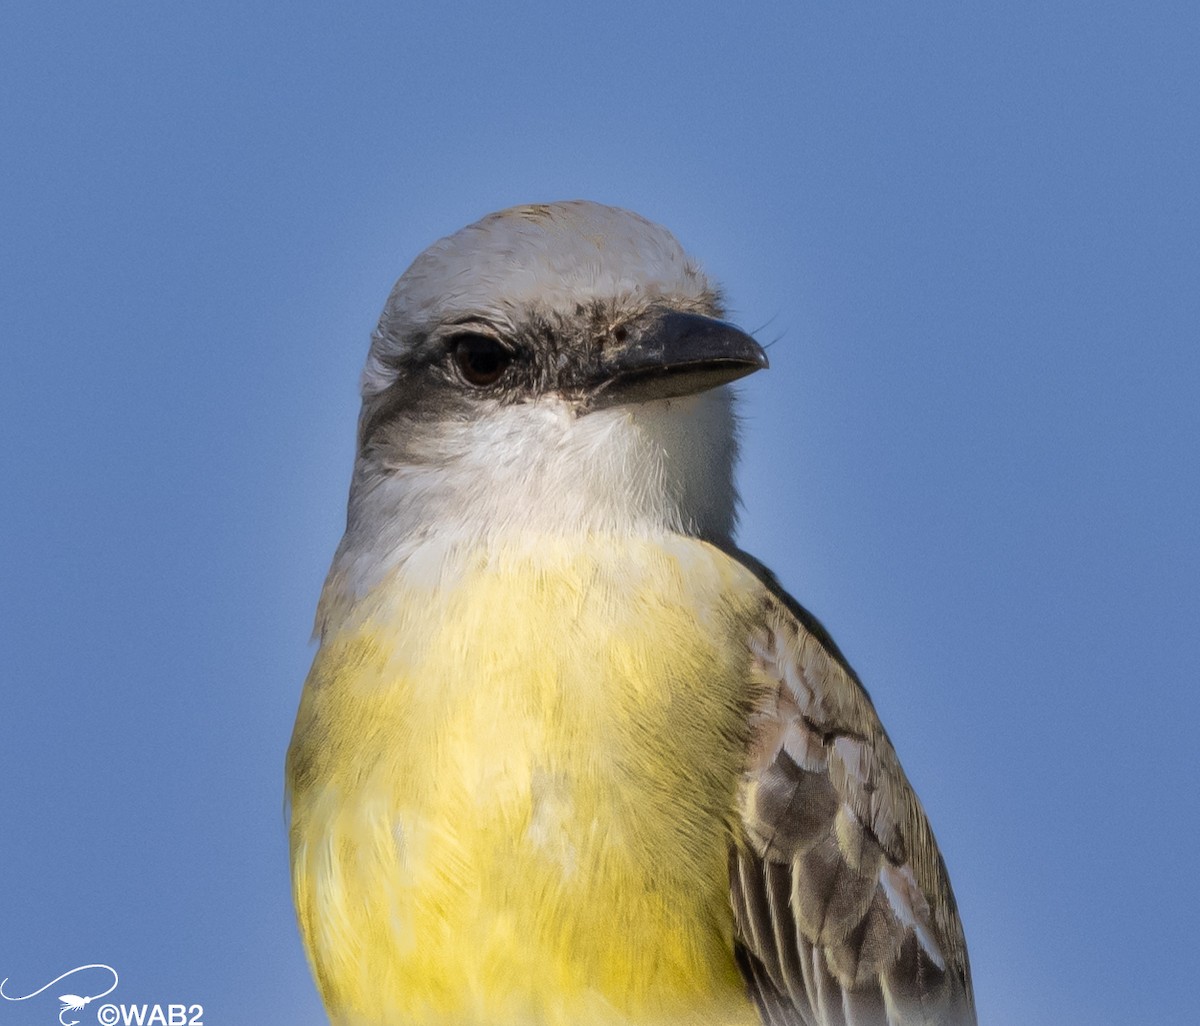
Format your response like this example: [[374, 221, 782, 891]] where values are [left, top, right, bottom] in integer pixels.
[[286, 200, 976, 1026]]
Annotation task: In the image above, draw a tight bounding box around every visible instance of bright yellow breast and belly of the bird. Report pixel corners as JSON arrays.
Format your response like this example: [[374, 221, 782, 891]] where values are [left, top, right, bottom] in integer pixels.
[[288, 539, 757, 1026]]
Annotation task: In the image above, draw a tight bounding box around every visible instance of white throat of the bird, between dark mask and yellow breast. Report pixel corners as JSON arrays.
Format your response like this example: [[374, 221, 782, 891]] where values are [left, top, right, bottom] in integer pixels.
[[318, 388, 737, 630]]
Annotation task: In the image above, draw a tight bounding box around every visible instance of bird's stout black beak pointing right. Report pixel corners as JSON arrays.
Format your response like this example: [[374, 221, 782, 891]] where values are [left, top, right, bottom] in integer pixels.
[[587, 311, 767, 409]]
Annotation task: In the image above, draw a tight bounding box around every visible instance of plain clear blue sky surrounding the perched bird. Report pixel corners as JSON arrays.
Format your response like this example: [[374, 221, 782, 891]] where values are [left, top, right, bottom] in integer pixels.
[[0, 6, 1200, 1026]]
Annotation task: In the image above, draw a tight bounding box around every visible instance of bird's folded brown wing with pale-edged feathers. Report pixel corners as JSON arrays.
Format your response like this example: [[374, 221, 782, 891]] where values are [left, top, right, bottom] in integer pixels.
[[730, 581, 976, 1026]]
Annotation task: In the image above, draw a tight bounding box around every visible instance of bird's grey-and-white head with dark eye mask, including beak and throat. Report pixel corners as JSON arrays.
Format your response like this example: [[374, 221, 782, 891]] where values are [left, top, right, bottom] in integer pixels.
[[336, 202, 767, 592]]
